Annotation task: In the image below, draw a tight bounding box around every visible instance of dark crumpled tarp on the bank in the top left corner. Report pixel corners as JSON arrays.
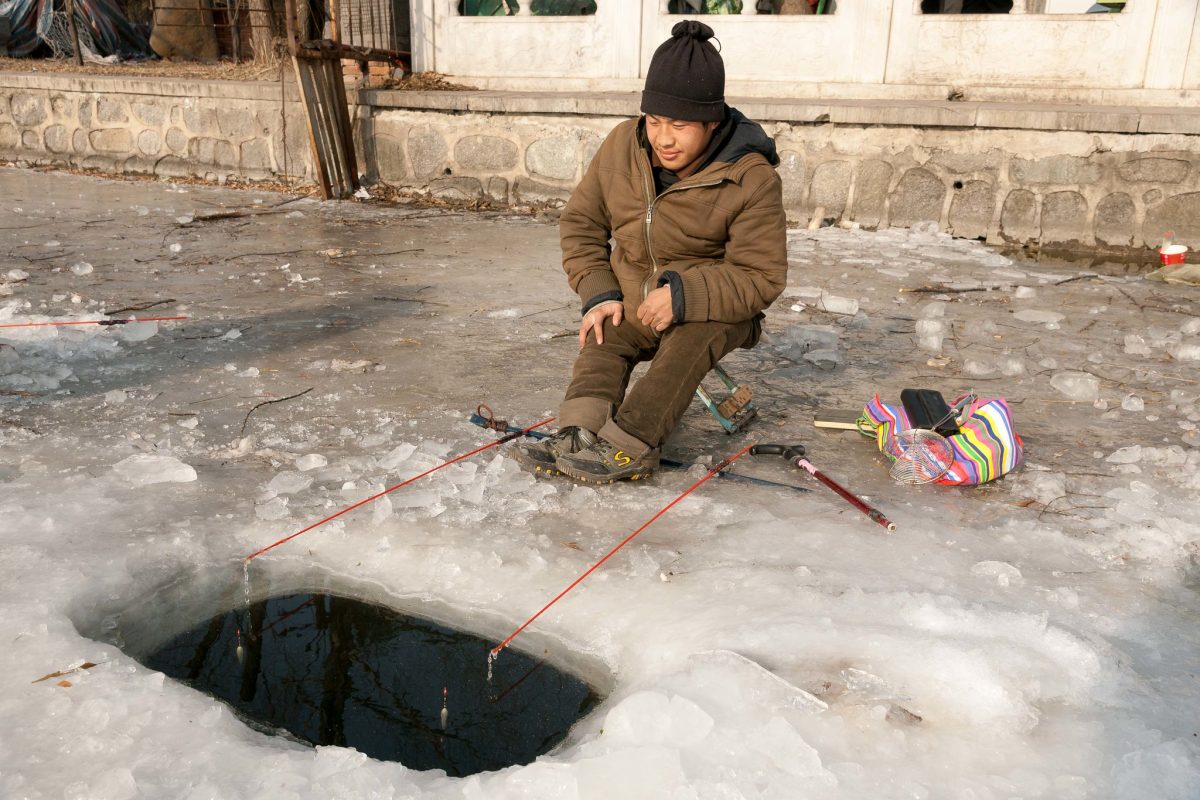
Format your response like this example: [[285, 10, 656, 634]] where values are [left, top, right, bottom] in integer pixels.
[[0, 0, 150, 59]]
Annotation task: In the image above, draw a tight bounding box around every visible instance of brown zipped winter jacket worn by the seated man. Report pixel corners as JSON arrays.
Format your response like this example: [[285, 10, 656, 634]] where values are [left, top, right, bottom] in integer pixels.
[[559, 109, 787, 323]]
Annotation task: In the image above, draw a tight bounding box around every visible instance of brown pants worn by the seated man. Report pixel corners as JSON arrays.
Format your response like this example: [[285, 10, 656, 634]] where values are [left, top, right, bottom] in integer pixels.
[[558, 309, 761, 457]]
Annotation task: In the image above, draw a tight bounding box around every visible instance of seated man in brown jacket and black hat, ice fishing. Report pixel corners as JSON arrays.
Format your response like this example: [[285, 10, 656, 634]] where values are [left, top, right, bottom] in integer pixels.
[[516, 20, 787, 483]]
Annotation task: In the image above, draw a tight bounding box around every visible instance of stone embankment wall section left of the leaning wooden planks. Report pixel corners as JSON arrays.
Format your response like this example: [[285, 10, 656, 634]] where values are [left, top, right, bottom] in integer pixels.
[[0, 73, 310, 181]]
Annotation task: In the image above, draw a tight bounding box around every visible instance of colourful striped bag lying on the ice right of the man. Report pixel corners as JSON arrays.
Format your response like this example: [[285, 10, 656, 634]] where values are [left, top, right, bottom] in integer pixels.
[[858, 395, 1022, 486]]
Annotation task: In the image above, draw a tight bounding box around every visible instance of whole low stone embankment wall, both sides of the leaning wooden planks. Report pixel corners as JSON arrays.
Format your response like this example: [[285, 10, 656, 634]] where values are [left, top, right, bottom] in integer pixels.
[[0, 74, 1200, 249]]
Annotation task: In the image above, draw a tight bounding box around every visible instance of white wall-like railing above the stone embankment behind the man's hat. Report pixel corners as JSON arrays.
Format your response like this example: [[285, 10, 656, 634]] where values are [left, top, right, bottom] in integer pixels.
[[412, 0, 1200, 96]]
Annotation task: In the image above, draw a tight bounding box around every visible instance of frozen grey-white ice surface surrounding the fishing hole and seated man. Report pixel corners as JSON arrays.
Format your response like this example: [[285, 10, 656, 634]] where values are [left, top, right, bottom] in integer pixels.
[[0, 178, 1200, 800]]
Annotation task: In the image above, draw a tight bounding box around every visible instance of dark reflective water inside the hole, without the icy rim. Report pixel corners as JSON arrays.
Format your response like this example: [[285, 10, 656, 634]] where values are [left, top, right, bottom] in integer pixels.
[[143, 594, 599, 776]]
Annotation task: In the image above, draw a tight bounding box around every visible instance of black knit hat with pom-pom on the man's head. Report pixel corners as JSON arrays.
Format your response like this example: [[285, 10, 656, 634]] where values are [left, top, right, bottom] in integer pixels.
[[642, 19, 725, 122]]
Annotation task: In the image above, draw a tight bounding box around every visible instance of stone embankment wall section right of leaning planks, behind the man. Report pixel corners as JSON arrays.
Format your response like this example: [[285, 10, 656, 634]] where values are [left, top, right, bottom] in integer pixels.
[[364, 100, 1200, 249]]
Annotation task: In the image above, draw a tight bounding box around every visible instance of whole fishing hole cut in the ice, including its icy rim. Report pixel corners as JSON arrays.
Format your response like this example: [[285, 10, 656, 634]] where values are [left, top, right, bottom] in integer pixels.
[[73, 564, 607, 777]]
